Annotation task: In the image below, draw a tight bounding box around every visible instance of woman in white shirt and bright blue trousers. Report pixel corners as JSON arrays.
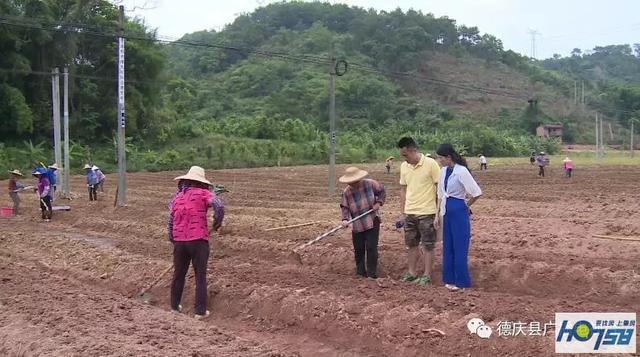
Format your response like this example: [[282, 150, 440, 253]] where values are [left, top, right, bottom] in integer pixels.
[[434, 144, 482, 290]]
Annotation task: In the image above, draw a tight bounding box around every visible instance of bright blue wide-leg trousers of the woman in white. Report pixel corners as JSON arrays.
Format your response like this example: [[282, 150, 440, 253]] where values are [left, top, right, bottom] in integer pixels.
[[442, 198, 471, 288]]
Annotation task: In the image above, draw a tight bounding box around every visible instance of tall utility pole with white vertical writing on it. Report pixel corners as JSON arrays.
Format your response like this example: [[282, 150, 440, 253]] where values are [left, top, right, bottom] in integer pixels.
[[116, 5, 127, 207]]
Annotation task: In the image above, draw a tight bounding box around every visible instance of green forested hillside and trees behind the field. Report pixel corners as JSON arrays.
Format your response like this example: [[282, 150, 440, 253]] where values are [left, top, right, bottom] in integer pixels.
[[0, 0, 640, 177]]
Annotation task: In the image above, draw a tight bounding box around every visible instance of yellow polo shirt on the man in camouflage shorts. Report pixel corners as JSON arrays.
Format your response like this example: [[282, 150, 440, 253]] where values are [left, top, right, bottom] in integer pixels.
[[400, 154, 440, 215]]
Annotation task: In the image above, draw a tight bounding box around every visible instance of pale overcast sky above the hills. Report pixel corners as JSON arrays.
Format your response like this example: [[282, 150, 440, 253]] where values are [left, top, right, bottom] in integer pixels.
[[116, 0, 640, 59]]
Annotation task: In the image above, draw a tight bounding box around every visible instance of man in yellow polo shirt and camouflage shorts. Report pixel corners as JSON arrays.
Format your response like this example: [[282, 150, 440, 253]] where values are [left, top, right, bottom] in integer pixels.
[[398, 137, 440, 285]]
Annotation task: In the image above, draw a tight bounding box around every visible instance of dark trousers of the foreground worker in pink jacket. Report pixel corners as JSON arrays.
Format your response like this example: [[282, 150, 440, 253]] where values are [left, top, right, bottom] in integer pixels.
[[171, 240, 209, 315]]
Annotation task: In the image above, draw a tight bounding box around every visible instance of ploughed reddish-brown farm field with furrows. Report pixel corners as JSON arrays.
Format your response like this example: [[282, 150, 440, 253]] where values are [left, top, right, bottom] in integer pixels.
[[0, 160, 640, 356]]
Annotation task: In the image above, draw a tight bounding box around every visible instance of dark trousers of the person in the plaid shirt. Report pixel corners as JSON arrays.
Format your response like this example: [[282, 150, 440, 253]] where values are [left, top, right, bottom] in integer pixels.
[[351, 217, 380, 278]]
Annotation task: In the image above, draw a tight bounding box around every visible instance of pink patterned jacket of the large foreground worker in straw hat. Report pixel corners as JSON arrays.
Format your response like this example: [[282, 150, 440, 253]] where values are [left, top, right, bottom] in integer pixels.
[[171, 188, 213, 242]]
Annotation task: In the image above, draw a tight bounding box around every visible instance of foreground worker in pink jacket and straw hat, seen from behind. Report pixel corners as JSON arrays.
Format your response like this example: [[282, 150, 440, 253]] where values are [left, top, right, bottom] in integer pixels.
[[169, 166, 224, 319]]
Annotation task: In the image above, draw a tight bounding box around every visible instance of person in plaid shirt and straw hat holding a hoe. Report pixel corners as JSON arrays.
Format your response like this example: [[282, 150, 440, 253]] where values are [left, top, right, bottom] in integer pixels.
[[338, 167, 386, 279]]
